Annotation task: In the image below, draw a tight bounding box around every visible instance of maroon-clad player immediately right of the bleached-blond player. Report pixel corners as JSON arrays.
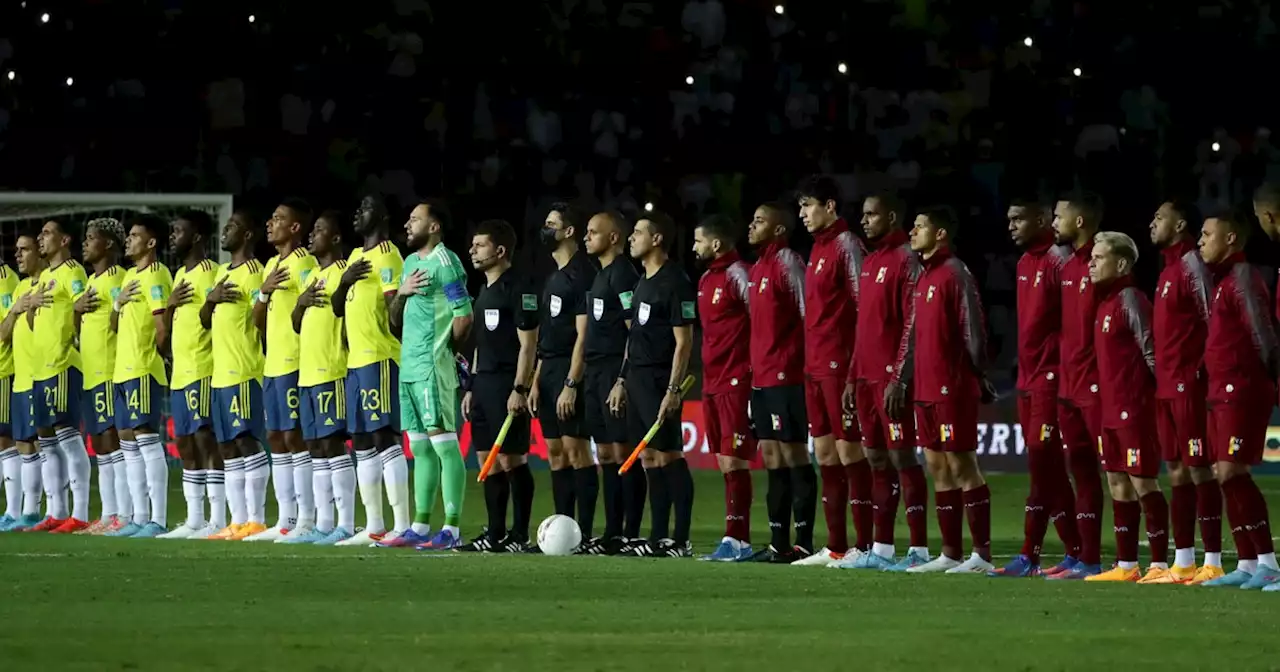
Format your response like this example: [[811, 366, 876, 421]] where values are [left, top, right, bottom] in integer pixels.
[[1147, 201, 1224, 584]]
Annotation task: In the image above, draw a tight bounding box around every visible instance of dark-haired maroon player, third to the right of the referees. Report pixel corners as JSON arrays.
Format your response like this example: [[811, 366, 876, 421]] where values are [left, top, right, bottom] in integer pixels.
[[795, 175, 867, 567]]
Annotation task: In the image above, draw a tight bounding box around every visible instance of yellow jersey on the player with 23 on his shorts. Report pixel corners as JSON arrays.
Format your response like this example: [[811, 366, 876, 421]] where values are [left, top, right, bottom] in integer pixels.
[[346, 241, 404, 369]]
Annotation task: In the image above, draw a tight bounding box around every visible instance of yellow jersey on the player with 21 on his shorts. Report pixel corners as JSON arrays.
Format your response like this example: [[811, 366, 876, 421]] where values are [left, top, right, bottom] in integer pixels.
[[32, 259, 88, 380]]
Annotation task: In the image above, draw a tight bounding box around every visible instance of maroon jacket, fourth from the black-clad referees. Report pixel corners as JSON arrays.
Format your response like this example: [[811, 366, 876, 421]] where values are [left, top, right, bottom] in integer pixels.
[[849, 229, 920, 383]]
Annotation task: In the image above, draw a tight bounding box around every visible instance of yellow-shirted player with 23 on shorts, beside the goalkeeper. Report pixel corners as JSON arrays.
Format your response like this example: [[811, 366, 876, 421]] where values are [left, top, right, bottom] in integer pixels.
[[330, 196, 411, 547]]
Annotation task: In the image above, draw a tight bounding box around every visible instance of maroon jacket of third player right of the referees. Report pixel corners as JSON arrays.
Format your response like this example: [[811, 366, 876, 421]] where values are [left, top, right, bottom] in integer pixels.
[[804, 219, 865, 380]]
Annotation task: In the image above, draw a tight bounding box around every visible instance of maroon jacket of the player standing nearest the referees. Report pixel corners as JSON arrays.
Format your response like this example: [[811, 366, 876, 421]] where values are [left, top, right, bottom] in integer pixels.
[[698, 252, 751, 394]]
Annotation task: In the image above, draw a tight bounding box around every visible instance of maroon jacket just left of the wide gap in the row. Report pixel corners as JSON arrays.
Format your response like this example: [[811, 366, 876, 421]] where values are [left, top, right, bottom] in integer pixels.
[[911, 250, 987, 403]]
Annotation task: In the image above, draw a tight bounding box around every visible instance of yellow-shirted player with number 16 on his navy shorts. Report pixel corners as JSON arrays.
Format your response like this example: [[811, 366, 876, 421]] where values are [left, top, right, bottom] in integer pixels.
[[158, 210, 227, 539]]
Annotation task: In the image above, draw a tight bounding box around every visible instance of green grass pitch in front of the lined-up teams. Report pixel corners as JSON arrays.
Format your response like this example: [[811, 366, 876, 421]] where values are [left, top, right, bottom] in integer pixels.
[[0, 472, 1280, 671]]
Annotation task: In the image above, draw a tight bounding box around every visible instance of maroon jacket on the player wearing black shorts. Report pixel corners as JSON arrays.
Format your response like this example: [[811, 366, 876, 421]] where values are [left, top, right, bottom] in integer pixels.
[[748, 241, 804, 388]]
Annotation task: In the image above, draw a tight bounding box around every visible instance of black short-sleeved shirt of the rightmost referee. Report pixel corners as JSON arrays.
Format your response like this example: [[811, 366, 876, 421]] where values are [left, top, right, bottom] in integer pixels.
[[627, 261, 698, 366]]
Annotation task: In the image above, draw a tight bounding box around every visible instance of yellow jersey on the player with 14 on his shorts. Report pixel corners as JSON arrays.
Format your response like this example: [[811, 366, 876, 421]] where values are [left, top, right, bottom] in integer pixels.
[[113, 261, 173, 385]]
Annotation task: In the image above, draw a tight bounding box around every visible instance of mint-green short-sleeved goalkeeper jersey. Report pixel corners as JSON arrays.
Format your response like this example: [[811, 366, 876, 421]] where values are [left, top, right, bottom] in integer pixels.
[[401, 244, 471, 387]]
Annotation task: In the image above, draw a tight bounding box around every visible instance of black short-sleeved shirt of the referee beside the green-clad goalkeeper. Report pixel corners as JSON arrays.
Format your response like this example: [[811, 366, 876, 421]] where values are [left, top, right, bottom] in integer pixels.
[[471, 269, 538, 374]]
